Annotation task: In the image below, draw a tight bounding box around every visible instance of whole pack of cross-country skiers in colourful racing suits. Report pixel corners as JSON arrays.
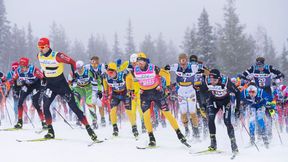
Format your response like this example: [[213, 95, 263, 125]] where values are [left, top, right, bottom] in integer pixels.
[[0, 38, 288, 153]]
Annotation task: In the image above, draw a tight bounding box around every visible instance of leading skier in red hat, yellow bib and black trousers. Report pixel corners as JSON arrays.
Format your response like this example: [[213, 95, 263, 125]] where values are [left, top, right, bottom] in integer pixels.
[[38, 38, 97, 141]]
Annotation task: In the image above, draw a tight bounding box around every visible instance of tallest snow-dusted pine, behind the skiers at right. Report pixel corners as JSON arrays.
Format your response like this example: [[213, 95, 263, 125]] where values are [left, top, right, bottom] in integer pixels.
[[217, 0, 255, 76]]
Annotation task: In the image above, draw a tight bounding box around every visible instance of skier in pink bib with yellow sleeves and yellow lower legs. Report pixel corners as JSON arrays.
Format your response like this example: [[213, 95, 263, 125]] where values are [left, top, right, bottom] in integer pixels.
[[133, 52, 186, 147]]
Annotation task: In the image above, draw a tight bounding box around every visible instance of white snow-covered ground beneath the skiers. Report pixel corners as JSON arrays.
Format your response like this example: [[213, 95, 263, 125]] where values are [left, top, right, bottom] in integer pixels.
[[0, 100, 288, 162]]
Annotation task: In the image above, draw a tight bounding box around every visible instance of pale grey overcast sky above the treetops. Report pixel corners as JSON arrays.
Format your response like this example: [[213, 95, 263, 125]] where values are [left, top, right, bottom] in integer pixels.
[[5, 0, 288, 52]]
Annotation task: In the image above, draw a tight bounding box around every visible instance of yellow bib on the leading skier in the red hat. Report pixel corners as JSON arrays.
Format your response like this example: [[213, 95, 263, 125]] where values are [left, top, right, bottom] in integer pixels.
[[38, 51, 64, 78]]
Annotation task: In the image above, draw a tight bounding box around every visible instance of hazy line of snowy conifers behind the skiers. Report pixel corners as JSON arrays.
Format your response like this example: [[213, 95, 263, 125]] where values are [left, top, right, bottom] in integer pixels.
[[0, 0, 288, 79]]
